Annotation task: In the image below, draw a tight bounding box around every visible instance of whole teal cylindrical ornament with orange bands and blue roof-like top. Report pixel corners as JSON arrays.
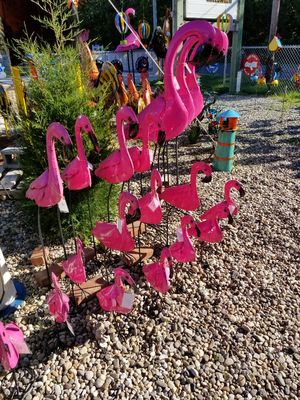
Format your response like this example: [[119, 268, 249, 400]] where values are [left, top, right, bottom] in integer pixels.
[[213, 110, 240, 172]]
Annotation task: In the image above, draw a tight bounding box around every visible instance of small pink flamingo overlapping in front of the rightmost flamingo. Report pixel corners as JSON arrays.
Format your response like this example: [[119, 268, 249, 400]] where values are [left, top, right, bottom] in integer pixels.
[[188, 201, 232, 243]]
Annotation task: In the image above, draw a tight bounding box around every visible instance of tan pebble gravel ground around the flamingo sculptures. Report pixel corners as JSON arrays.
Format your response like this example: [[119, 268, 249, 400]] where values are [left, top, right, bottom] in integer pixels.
[[0, 96, 300, 400]]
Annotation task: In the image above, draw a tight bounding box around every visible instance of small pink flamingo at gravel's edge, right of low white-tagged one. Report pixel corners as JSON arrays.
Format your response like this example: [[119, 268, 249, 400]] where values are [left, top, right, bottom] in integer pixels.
[[143, 247, 172, 293]]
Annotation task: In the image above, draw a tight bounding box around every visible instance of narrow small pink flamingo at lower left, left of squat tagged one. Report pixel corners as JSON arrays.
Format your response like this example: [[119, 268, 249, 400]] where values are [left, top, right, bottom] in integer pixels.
[[47, 272, 70, 323]]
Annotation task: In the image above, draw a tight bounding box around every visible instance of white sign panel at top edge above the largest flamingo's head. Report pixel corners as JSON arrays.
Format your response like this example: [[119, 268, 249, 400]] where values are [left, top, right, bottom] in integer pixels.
[[184, 0, 239, 19]]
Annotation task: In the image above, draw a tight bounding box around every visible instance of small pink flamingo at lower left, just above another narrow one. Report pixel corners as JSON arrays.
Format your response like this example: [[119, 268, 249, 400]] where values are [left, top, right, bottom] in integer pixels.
[[61, 239, 86, 285]]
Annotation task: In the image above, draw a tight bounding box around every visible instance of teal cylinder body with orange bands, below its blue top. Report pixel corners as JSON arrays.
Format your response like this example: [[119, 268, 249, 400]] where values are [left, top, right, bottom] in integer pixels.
[[213, 131, 236, 172]]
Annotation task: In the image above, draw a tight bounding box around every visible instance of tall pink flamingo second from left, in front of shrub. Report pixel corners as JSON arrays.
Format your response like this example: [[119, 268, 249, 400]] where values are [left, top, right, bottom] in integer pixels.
[[61, 115, 99, 190]]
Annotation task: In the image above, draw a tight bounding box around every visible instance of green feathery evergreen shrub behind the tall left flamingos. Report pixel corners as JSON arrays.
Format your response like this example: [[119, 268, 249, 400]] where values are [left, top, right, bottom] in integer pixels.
[[15, 0, 119, 244]]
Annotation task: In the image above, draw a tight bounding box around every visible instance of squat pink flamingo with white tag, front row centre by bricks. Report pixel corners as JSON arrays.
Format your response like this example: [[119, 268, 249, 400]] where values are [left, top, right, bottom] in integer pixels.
[[96, 268, 134, 314]]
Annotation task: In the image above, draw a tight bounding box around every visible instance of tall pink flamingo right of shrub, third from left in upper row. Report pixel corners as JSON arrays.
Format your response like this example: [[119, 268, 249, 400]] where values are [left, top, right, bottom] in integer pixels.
[[95, 106, 138, 183]]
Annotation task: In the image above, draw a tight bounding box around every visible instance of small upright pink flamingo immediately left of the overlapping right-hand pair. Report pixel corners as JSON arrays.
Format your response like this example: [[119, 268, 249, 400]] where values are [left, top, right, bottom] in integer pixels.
[[170, 215, 196, 263]]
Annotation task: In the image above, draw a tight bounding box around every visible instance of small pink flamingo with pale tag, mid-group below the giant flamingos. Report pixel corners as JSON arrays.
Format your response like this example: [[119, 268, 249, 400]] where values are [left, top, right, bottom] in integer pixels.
[[139, 169, 162, 224]]
